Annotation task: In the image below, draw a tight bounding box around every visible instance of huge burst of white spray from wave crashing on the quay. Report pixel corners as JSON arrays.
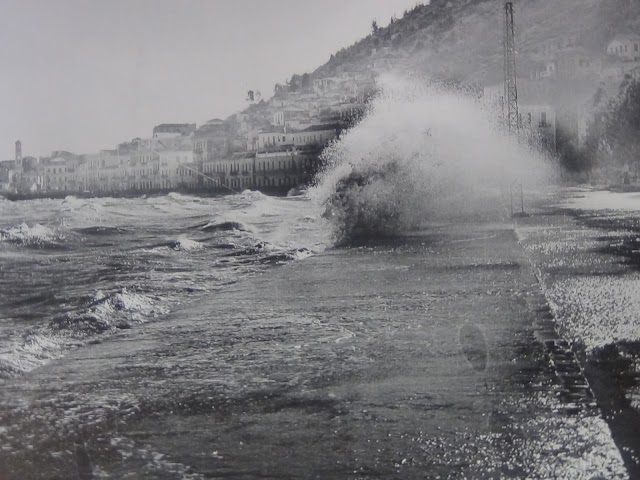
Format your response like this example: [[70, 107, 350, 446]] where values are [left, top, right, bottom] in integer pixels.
[[311, 76, 553, 241]]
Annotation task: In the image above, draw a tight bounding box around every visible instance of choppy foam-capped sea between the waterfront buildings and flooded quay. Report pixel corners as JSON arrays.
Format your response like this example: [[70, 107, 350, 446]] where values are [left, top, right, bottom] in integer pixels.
[[0, 191, 329, 378]]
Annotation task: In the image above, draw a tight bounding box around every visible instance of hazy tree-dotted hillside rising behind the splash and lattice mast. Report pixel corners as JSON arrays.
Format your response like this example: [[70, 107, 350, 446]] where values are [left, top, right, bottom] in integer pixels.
[[235, 0, 640, 174]]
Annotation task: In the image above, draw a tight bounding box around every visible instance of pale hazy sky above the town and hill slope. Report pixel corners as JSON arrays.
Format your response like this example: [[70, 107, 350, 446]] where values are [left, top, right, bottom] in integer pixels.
[[0, 0, 425, 159]]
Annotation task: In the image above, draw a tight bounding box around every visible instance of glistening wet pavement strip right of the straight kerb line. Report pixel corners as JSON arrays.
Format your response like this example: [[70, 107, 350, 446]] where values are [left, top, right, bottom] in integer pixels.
[[517, 189, 640, 478]]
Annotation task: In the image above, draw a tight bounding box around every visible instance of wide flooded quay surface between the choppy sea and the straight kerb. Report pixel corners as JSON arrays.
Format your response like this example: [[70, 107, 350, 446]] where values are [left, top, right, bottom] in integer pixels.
[[0, 222, 627, 479]]
